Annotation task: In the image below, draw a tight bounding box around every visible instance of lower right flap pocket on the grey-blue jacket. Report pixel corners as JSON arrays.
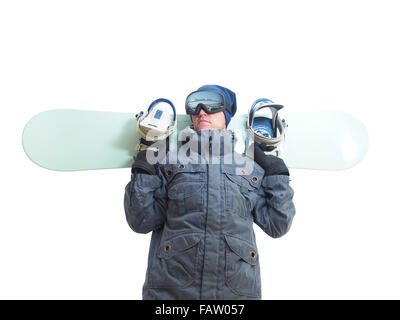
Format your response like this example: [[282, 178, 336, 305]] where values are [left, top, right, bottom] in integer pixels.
[[225, 235, 261, 298]]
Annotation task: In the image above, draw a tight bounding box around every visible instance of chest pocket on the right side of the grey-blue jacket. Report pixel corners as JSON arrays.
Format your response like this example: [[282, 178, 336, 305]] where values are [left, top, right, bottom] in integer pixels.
[[224, 168, 262, 218]]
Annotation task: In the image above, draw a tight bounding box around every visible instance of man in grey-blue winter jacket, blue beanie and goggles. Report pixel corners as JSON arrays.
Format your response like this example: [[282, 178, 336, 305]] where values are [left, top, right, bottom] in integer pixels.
[[124, 85, 295, 299]]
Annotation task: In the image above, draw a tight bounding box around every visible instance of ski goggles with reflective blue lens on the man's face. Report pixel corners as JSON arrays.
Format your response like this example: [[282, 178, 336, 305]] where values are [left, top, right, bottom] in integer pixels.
[[185, 91, 225, 115]]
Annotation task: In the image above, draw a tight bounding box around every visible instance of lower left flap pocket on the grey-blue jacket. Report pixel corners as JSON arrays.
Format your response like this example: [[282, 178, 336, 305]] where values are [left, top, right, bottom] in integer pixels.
[[148, 233, 202, 288]]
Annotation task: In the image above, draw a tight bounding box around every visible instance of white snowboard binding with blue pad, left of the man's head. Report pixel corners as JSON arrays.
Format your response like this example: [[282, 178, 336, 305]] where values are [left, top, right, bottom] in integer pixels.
[[135, 98, 177, 151]]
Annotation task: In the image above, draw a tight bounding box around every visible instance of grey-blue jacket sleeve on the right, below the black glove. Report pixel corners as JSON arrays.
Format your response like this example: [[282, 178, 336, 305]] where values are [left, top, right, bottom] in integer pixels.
[[252, 175, 296, 238]]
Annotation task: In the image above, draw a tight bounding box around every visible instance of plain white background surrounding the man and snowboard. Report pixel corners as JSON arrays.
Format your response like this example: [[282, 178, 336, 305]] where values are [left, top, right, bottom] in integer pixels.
[[0, 0, 400, 299]]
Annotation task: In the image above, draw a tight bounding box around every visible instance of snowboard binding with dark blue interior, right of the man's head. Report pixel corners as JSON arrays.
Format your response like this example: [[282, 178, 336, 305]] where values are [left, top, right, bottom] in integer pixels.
[[246, 98, 287, 156]]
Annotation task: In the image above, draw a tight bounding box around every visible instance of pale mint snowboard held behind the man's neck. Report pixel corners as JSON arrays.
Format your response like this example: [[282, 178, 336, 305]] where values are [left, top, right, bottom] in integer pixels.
[[22, 109, 369, 171]]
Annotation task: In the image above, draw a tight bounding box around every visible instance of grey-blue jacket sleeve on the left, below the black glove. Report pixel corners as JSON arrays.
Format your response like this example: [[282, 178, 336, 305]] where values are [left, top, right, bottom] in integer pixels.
[[124, 169, 167, 233]]
